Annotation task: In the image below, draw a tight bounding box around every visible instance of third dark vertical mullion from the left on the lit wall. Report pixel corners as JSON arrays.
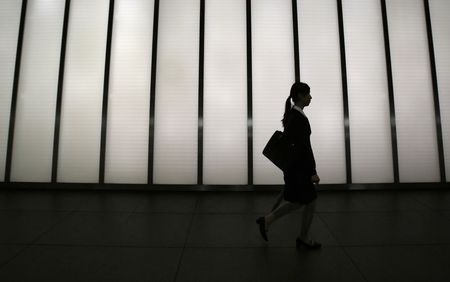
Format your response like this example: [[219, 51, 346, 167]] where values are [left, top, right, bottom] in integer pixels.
[[99, 0, 114, 184]]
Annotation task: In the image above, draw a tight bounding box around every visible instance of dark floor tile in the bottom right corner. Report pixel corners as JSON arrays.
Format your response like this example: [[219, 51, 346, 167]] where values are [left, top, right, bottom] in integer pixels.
[[346, 245, 450, 282]]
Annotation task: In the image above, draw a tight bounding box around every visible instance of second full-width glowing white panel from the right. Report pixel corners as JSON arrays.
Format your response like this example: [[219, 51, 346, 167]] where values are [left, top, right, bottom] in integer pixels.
[[342, 0, 394, 183]]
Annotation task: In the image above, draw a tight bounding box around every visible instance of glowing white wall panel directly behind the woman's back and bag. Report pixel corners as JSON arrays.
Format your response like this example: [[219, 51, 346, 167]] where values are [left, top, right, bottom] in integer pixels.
[[252, 0, 295, 184]]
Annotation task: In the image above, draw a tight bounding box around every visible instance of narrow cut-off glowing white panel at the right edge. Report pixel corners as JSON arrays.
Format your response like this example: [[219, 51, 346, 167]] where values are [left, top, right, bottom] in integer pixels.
[[430, 0, 450, 181]]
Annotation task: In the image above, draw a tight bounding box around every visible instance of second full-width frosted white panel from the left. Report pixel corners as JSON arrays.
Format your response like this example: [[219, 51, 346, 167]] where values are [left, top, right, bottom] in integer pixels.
[[57, 0, 109, 182]]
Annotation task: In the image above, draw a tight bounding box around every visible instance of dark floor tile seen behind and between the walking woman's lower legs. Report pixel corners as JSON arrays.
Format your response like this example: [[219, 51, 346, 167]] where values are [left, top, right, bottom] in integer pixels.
[[188, 214, 336, 247]]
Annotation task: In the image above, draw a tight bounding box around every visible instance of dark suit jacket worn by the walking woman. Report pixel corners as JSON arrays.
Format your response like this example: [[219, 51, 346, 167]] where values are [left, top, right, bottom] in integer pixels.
[[283, 108, 317, 178]]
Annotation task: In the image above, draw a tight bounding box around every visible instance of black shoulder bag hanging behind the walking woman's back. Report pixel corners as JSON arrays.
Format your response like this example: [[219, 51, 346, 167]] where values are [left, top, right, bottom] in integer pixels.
[[263, 130, 294, 171]]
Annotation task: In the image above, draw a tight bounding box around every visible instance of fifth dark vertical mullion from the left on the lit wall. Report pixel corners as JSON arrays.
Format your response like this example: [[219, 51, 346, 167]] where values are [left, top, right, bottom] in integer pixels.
[[197, 0, 205, 185]]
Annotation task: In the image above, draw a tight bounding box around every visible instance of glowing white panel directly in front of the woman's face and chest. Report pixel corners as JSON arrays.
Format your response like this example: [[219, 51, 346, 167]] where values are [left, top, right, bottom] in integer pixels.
[[298, 0, 346, 183]]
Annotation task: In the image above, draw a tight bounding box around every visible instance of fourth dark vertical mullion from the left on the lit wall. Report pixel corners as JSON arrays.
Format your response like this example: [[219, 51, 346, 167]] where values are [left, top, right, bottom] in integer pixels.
[[147, 0, 159, 184]]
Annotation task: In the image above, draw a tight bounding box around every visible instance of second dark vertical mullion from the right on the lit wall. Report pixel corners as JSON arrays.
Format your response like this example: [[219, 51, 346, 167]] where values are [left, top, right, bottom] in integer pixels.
[[380, 0, 399, 183]]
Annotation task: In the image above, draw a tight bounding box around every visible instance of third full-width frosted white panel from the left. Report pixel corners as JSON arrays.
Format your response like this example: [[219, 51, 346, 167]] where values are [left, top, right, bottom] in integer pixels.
[[105, 0, 154, 183]]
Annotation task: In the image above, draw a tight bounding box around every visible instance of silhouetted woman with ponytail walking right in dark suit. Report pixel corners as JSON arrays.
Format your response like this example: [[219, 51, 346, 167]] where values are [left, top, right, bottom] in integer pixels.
[[256, 82, 321, 249]]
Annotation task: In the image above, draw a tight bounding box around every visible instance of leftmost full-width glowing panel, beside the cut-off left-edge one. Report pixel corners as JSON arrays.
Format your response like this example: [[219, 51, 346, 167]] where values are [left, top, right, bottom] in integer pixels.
[[11, 0, 65, 182]]
